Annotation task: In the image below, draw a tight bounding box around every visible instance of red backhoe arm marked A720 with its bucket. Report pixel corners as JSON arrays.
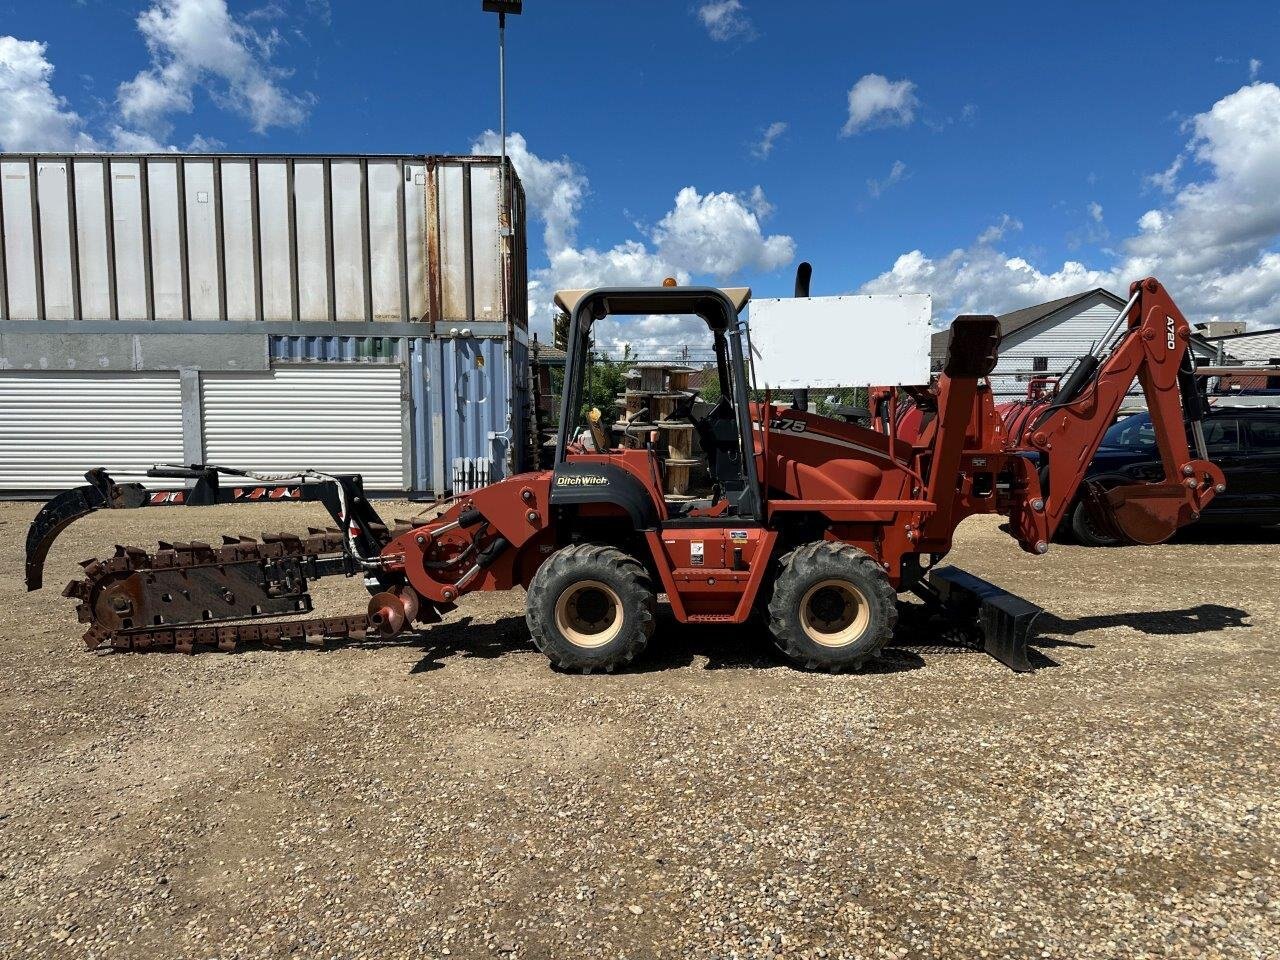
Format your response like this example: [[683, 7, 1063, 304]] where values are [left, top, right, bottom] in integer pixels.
[[1024, 278, 1226, 544]]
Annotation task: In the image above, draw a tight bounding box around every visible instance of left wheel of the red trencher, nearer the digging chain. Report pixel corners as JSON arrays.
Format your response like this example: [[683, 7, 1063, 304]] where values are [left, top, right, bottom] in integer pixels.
[[525, 544, 658, 673]]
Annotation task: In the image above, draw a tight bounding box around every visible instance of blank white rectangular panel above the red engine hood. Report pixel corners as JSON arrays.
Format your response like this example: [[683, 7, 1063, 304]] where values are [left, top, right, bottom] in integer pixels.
[[751, 293, 933, 388]]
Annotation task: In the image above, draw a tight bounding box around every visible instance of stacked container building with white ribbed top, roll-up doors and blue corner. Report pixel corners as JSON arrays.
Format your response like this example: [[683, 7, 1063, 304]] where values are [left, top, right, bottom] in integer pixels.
[[0, 154, 527, 495]]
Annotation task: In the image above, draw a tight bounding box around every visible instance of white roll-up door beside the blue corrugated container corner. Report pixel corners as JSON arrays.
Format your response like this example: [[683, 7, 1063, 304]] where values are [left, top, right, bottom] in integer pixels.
[[201, 364, 404, 490]]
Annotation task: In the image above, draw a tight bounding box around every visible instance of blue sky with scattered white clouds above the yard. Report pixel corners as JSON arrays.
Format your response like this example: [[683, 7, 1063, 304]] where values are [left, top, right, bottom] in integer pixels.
[[0, 0, 1280, 350]]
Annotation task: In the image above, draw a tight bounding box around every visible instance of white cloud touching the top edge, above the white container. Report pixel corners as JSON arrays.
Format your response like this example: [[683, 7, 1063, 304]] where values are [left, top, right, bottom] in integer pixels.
[[116, 0, 311, 137]]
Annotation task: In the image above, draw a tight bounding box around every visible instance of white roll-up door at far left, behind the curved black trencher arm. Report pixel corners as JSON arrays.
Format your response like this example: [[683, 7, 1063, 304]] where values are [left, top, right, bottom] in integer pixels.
[[0, 370, 182, 492]]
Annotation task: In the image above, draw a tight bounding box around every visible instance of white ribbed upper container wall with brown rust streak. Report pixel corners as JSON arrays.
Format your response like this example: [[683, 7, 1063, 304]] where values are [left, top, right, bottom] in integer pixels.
[[0, 154, 527, 326]]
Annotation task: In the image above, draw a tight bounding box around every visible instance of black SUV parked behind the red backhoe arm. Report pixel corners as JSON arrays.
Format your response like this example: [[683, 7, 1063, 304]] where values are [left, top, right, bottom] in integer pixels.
[[1069, 407, 1280, 547]]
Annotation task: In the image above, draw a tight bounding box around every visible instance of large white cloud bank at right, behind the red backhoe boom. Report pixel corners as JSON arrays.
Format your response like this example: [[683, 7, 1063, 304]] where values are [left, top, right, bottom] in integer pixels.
[[863, 83, 1280, 324]]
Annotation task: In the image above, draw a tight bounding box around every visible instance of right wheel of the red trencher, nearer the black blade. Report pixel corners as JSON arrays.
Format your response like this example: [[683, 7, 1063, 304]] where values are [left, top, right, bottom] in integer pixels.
[[769, 540, 897, 673]]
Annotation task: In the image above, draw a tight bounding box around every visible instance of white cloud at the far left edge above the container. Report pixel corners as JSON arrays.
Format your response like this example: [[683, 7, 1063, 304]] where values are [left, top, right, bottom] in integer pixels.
[[0, 36, 97, 151]]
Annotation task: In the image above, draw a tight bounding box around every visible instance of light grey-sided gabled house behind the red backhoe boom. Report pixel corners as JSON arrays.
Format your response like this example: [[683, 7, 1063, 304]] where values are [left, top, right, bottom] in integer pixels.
[[929, 287, 1215, 402]]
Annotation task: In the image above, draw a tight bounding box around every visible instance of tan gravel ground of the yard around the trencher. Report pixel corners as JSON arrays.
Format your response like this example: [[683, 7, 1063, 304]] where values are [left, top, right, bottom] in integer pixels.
[[0, 503, 1280, 960]]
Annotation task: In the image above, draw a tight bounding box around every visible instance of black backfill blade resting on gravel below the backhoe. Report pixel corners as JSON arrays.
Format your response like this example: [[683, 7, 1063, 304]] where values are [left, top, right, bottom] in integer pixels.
[[929, 567, 1043, 673]]
